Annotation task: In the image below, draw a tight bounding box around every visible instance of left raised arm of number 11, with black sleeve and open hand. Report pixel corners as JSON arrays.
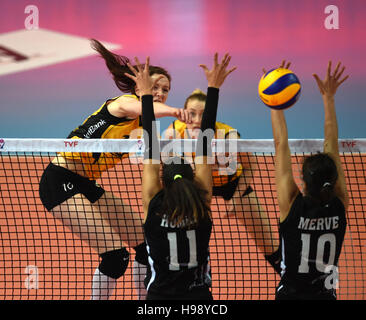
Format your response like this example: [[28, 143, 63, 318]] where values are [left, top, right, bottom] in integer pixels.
[[126, 57, 162, 218]]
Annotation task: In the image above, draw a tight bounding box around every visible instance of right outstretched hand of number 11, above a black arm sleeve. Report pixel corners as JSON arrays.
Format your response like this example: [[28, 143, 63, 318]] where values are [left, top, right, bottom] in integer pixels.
[[199, 52, 236, 89]]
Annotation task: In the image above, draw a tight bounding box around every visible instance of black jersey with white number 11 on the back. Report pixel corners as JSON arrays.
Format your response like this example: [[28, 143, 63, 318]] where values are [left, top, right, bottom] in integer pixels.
[[144, 190, 212, 297]]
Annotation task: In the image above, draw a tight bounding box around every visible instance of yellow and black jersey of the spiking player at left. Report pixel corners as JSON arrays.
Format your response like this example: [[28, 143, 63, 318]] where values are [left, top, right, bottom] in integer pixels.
[[60, 95, 141, 180]]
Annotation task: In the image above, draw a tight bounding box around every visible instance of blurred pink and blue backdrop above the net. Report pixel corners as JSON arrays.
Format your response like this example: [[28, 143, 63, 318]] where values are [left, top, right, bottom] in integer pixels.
[[0, 0, 366, 139]]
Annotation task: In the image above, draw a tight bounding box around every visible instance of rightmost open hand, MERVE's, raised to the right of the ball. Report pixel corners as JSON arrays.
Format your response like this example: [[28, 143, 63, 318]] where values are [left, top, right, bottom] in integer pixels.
[[313, 61, 349, 97]]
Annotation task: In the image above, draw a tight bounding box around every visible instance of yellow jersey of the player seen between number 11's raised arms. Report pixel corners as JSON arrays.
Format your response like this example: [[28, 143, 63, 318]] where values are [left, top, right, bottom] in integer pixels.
[[171, 120, 243, 187]]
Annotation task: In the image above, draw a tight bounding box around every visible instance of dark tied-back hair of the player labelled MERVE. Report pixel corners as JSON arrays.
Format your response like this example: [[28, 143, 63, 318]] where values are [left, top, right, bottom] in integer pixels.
[[302, 153, 338, 205]]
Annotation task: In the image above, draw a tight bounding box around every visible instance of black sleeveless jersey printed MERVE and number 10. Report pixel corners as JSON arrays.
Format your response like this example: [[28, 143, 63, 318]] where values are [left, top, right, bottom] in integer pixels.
[[279, 193, 347, 292]]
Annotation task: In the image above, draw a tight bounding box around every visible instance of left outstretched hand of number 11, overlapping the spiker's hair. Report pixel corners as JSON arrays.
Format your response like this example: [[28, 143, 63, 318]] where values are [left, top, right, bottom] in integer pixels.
[[125, 57, 164, 96]]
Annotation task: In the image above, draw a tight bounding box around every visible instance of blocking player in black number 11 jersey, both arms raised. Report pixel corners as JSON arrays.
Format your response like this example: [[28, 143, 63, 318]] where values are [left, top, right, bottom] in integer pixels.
[[124, 54, 235, 300]]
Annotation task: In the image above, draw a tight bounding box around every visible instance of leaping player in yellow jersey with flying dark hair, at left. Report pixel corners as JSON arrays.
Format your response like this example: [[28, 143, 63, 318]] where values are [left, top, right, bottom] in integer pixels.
[[39, 40, 189, 300]]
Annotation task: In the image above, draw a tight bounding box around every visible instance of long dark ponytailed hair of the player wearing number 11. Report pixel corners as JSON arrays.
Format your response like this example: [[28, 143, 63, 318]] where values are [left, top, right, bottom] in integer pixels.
[[162, 158, 211, 228]]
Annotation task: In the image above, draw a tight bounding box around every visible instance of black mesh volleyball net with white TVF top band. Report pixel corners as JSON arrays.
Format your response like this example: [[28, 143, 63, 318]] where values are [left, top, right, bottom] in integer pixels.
[[0, 139, 366, 300]]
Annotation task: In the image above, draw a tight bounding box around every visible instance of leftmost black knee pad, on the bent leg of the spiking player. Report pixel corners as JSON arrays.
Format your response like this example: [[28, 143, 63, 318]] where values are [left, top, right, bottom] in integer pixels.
[[99, 248, 130, 279]]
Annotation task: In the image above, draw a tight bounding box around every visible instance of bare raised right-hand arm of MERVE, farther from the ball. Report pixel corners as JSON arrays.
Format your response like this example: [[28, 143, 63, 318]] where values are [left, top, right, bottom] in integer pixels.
[[313, 61, 349, 209]]
